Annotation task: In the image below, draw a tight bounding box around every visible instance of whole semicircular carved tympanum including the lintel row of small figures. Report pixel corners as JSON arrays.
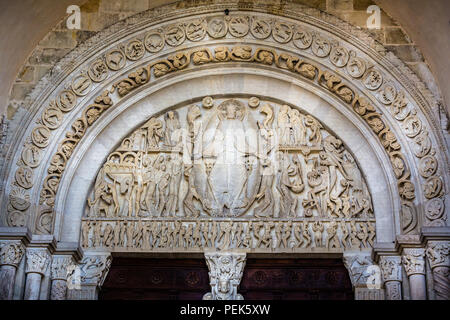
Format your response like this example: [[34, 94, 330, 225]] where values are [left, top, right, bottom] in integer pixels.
[[81, 97, 375, 252]]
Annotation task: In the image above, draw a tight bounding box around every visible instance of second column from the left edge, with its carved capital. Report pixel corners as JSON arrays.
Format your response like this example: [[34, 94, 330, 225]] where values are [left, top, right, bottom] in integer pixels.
[[24, 248, 51, 300]]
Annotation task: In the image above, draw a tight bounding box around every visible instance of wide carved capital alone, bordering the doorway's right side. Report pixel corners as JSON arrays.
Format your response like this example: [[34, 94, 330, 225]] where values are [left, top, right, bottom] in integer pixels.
[[344, 252, 381, 289]]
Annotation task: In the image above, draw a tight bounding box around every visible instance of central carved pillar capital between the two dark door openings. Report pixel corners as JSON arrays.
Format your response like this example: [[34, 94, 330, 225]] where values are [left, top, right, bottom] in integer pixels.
[[203, 252, 246, 300]]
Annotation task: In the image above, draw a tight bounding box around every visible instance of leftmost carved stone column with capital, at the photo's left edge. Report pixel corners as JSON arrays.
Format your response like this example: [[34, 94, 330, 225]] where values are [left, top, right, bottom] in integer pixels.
[[0, 241, 25, 300]]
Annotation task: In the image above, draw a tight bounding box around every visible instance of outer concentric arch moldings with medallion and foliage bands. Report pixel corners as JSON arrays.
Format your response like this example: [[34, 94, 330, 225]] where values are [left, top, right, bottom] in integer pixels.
[[2, 2, 448, 238]]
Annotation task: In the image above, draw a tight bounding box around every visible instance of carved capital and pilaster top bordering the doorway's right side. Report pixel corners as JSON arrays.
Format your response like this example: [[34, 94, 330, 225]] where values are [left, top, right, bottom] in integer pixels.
[[344, 252, 384, 300]]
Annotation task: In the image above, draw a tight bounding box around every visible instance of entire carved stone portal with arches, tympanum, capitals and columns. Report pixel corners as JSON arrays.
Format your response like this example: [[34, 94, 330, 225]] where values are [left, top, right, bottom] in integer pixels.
[[0, 1, 449, 299]]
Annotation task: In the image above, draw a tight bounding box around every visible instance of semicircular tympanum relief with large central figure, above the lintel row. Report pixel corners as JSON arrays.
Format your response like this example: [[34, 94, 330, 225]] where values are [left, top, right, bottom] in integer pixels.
[[83, 97, 374, 251]]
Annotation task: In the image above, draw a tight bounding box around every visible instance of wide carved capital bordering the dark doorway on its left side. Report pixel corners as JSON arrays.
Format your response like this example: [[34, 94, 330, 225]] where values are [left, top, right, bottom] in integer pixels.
[[79, 255, 112, 287]]
